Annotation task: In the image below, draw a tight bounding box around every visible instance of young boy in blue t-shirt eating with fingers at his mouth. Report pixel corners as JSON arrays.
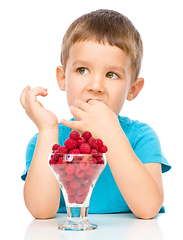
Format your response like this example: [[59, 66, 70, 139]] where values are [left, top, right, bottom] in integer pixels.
[[20, 10, 170, 219]]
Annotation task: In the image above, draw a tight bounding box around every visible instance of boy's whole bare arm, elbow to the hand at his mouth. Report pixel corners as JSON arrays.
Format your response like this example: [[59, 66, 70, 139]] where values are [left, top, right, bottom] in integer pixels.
[[61, 100, 163, 219]]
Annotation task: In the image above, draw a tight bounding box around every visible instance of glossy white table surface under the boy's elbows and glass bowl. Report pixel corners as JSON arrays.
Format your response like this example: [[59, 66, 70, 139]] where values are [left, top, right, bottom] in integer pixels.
[[21, 214, 180, 240]]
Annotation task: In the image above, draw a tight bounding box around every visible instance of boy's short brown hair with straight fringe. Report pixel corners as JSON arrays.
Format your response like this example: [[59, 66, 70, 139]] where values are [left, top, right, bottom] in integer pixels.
[[61, 9, 143, 81]]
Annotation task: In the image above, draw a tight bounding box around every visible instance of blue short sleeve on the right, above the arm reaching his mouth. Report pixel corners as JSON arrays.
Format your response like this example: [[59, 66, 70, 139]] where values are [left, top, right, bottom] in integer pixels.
[[131, 123, 171, 173]]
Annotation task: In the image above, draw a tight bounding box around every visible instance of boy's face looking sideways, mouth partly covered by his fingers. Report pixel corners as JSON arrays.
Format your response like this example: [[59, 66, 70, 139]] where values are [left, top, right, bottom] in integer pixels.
[[57, 41, 135, 115]]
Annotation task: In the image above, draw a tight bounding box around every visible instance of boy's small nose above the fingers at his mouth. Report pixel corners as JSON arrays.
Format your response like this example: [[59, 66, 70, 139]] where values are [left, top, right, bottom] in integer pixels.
[[87, 74, 105, 93]]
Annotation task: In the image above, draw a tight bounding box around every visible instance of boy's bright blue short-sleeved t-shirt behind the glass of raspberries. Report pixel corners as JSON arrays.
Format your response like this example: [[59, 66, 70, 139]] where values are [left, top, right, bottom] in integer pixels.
[[21, 116, 171, 213]]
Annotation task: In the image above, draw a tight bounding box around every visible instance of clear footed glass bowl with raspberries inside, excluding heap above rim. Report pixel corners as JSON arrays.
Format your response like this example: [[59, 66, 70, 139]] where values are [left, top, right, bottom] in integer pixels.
[[49, 153, 107, 231]]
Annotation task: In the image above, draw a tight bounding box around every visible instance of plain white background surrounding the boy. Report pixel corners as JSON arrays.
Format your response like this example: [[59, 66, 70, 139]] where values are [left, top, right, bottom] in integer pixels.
[[0, 0, 183, 239]]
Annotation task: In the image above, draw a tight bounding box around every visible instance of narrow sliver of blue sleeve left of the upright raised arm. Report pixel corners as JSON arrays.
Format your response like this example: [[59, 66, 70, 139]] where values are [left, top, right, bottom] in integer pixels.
[[21, 134, 38, 181]]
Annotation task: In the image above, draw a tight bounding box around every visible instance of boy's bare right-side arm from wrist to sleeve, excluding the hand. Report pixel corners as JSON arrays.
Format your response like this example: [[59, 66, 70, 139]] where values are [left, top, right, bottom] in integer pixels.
[[103, 125, 164, 219]]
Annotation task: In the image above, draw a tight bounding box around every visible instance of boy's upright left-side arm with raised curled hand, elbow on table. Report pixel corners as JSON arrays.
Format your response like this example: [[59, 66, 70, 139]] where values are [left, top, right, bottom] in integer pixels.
[[20, 86, 60, 218]]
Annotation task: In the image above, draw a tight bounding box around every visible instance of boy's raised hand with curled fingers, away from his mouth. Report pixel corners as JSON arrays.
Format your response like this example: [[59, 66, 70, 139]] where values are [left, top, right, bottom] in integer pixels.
[[20, 86, 58, 130]]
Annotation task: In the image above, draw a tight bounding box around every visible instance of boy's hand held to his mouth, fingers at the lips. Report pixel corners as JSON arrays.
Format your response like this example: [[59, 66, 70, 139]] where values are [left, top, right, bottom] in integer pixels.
[[61, 100, 120, 140]]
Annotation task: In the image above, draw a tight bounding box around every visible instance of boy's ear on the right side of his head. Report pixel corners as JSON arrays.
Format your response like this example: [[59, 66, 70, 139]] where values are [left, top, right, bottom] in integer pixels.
[[126, 78, 144, 101]]
